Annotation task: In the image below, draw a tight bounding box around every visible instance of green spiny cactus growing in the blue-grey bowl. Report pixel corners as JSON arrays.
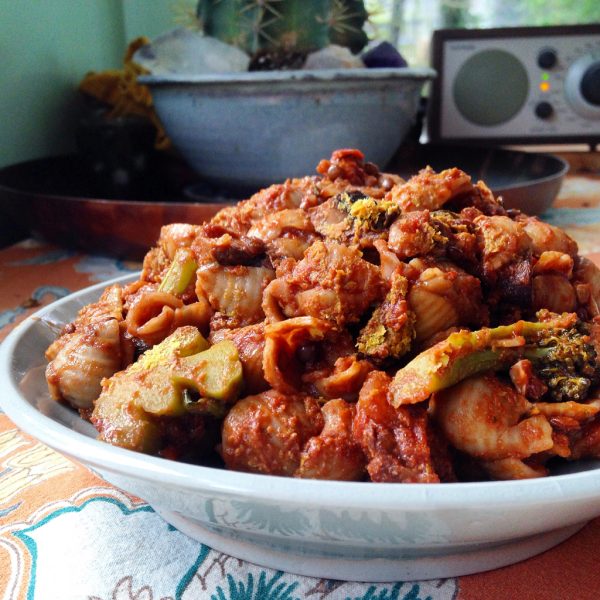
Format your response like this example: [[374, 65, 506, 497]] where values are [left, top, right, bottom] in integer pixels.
[[196, 0, 367, 55]]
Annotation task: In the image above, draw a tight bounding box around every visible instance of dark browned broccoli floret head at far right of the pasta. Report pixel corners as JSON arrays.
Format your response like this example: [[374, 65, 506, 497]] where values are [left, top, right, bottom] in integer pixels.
[[524, 321, 600, 402]]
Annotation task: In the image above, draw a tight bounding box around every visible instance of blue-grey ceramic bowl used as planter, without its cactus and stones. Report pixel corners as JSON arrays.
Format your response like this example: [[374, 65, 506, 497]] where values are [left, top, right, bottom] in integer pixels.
[[139, 68, 435, 190]]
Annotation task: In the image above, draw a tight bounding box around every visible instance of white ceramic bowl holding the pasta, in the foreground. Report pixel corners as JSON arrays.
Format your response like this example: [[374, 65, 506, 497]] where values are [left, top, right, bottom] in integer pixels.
[[0, 276, 600, 581]]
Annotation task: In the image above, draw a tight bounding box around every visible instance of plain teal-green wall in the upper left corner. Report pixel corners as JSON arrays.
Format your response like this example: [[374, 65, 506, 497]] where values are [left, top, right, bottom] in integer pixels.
[[0, 0, 174, 167]]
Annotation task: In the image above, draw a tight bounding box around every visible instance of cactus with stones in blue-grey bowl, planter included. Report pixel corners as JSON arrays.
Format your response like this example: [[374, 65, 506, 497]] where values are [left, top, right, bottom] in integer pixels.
[[134, 0, 434, 193]]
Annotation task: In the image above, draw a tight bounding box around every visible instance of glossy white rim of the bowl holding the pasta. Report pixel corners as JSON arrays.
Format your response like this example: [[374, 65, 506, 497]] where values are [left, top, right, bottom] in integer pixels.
[[0, 273, 600, 512]]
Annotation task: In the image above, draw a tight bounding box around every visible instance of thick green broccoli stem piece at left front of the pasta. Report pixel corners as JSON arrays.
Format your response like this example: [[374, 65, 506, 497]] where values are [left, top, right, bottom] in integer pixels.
[[91, 326, 243, 453]]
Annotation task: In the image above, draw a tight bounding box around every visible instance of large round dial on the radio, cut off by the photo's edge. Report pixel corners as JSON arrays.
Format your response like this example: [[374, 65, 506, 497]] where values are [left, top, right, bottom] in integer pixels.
[[565, 54, 600, 119]]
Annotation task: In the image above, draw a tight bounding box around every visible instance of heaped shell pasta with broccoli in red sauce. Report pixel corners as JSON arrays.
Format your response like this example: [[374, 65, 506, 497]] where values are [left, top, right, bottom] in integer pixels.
[[46, 149, 600, 483]]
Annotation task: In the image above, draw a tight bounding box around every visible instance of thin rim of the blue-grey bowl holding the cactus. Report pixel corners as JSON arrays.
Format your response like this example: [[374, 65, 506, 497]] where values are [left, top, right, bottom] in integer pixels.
[[137, 67, 437, 87]]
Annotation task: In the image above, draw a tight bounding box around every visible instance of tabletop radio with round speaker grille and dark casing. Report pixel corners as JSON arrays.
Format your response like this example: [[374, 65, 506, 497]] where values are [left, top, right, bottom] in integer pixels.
[[427, 24, 600, 146]]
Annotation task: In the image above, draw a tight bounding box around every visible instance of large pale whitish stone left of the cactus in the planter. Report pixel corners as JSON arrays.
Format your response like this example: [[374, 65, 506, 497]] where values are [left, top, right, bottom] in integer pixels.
[[133, 27, 250, 75]]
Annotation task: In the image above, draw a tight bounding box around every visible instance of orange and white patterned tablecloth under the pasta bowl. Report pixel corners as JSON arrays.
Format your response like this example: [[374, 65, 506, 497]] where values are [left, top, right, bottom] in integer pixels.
[[0, 175, 600, 600]]
